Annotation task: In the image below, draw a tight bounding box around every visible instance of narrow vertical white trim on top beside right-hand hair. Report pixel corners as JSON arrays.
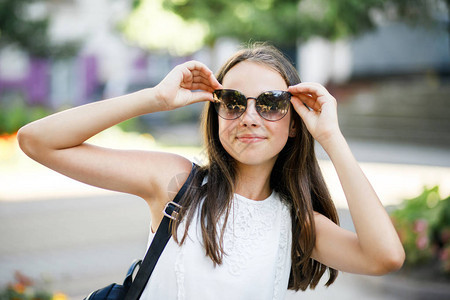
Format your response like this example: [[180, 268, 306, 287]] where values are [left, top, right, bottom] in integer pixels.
[[273, 205, 292, 299]]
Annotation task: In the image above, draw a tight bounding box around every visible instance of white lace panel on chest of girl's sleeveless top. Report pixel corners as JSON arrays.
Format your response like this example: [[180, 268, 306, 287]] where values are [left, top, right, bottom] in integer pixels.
[[219, 195, 281, 276]]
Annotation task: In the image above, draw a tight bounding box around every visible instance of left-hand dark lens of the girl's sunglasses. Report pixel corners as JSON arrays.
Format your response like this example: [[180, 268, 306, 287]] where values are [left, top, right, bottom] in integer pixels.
[[213, 90, 247, 120]]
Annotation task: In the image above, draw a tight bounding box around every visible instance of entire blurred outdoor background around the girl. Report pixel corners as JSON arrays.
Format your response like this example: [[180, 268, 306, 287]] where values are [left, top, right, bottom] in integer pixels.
[[0, 0, 450, 299]]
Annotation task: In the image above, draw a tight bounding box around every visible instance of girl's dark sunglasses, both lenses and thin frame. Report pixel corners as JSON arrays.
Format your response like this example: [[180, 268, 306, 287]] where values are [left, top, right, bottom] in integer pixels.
[[213, 89, 292, 121]]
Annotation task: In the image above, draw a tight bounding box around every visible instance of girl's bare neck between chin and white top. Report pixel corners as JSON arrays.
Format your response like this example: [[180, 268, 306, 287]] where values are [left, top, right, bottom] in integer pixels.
[[236, 163, 273, 200]]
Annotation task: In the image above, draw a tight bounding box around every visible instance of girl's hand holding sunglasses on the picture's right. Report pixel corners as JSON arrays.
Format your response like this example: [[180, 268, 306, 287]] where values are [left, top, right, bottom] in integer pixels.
[[288, 82, 341, 146]]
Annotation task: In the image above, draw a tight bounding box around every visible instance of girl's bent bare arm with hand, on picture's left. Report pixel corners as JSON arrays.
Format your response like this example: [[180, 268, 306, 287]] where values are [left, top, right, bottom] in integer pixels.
[[18, 62, 220, 227]]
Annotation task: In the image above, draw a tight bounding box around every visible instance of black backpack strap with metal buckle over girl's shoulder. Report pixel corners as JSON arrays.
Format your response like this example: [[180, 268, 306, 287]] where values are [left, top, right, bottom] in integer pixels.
[[125, 163, 198, 300]]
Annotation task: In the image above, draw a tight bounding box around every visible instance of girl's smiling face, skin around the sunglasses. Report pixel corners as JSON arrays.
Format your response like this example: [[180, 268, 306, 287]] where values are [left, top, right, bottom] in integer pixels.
[[218, 61, 294, 167]]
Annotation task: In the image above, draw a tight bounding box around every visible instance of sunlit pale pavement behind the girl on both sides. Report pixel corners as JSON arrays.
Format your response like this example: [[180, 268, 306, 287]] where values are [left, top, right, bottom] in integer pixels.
[[0, 137, 450, 300]]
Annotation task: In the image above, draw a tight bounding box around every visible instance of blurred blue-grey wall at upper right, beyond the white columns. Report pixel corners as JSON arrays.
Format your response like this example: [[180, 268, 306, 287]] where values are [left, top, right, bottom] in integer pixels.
[[351, 22, 450, 76]]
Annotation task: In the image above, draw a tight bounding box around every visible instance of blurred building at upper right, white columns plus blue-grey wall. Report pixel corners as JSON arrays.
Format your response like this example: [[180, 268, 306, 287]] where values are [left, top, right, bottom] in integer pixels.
[[298, 18, 450, 84]]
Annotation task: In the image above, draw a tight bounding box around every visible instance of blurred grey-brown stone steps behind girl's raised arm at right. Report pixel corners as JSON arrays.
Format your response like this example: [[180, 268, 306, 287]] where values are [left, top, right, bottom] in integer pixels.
[[338, 78, 450, 146]]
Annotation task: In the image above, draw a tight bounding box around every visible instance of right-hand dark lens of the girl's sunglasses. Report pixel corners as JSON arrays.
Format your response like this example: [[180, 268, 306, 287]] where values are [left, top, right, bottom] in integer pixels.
[[256, 91, 291, 121]]
